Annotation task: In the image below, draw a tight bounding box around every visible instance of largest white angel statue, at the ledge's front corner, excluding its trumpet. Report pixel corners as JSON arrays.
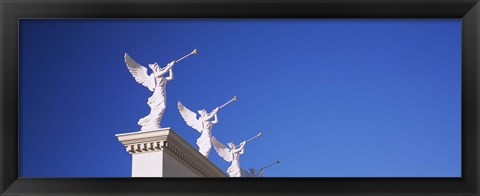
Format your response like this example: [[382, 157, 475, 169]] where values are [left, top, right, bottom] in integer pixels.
[[125, 53, 175, 131]]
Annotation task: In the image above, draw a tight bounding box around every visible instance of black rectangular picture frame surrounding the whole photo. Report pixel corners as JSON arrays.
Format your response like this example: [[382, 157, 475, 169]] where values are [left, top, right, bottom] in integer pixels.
[[0, 0, 480, 196]]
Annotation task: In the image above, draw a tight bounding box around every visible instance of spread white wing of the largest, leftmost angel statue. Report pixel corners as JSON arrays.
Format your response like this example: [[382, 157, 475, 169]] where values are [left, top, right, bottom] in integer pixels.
[[125, 53, 155, 91]]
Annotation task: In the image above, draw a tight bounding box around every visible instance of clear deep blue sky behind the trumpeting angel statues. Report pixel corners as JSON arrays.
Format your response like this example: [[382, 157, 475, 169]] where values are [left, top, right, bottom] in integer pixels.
[[19, 19, 461, 177]]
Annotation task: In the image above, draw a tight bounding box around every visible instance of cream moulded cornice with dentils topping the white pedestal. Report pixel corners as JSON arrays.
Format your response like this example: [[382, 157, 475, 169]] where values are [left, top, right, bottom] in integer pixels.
[[115, 128, 227, 177]]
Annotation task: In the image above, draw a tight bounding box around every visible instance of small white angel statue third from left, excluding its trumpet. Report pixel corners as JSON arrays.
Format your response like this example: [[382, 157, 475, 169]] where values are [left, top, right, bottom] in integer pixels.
[[212, 137, 247, 177]]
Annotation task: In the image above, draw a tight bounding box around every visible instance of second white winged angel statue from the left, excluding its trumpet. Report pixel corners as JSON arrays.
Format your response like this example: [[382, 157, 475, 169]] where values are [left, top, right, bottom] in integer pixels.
[[178, 101, 220, 157]]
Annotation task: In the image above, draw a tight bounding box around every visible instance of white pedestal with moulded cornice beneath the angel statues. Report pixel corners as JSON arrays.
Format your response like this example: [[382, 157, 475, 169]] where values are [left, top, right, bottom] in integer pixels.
[[115, 128, 227, 177]]
